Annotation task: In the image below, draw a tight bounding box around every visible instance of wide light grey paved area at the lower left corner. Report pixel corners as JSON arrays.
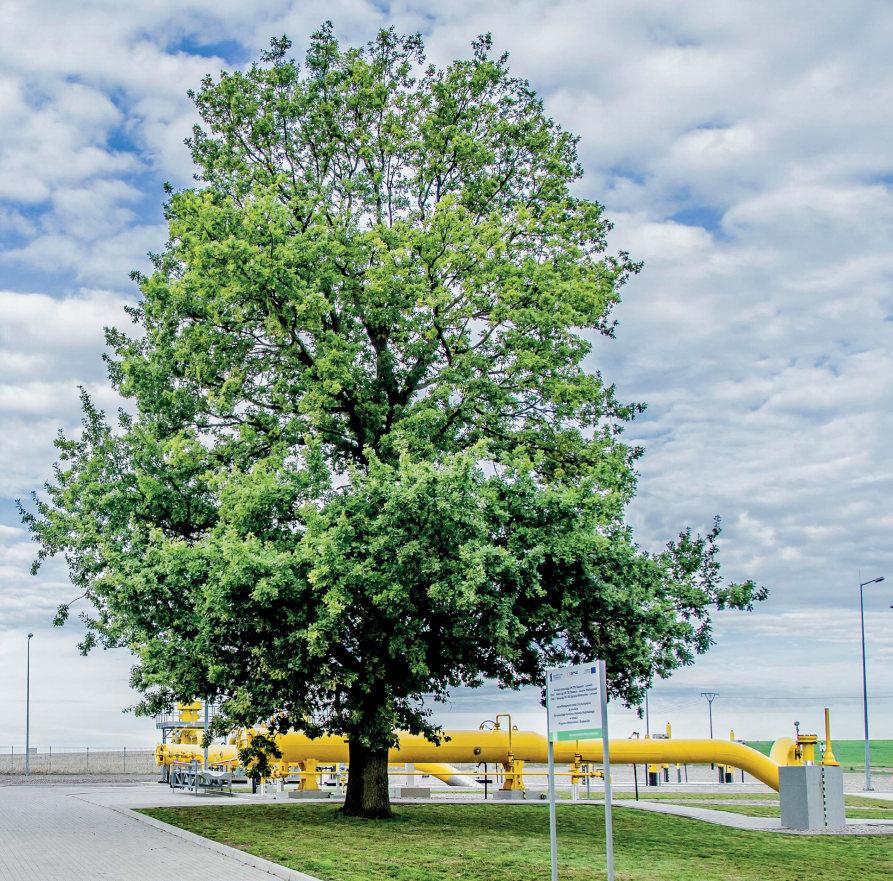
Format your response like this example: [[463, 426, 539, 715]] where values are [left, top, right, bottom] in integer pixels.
[[0, 785, 316, 881]]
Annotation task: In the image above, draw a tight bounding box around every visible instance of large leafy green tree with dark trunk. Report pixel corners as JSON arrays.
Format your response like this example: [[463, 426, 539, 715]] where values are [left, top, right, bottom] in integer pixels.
[[23, 25, 762, 816]]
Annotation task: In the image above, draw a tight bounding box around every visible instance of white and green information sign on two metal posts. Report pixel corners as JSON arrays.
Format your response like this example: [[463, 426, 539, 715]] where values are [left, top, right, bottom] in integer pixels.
[[546, 661, 614, 881]]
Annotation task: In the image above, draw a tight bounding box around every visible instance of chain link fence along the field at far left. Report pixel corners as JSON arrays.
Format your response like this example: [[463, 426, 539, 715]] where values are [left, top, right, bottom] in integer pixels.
[[0, 746, 157, 774]]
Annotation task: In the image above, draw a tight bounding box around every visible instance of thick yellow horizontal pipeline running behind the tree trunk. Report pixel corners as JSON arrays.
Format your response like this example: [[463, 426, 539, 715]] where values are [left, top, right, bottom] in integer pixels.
[[233, 731, 789, 790]]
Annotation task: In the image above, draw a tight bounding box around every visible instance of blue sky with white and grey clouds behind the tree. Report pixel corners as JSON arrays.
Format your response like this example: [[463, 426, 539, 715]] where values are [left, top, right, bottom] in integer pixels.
[[0, 0, 893, 752]]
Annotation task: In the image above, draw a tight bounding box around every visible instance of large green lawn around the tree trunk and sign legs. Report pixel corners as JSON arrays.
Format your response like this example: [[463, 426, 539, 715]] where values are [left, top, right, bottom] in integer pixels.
[[143, 804, 893, 881]]
